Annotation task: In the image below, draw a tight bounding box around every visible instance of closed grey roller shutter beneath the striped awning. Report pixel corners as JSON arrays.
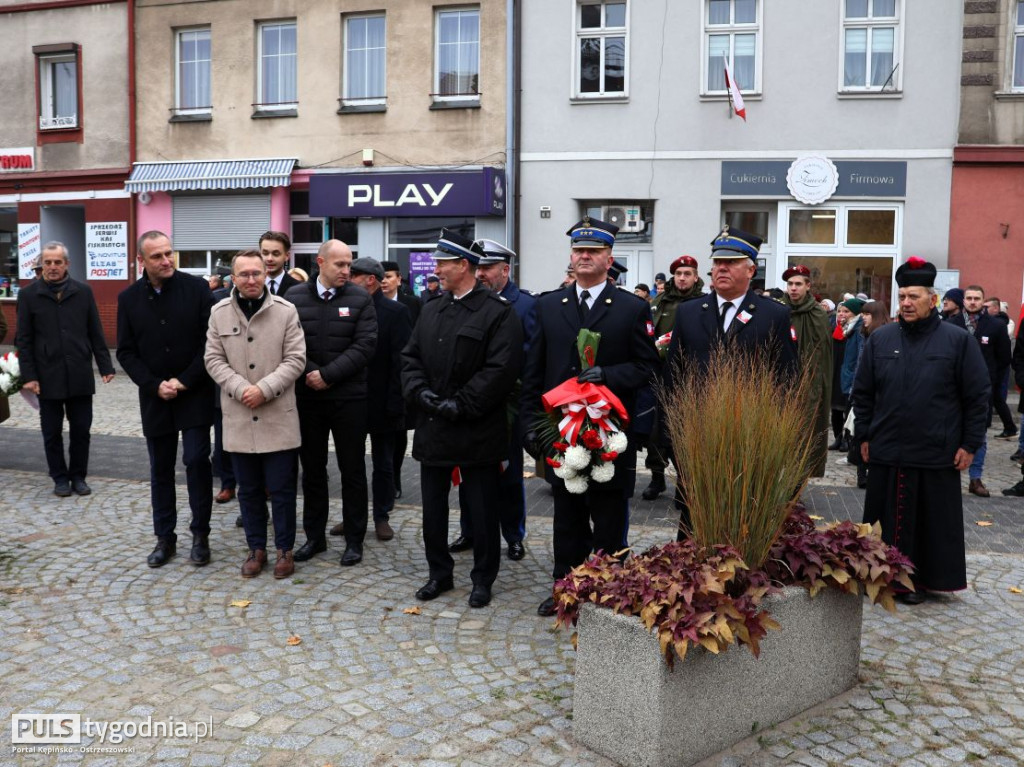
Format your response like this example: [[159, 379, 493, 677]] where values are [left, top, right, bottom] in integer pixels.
[[172, 193, 270, 250]]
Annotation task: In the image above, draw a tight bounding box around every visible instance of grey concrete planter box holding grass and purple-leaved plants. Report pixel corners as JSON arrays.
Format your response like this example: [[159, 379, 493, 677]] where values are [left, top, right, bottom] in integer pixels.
[[572, 587, 861, 767]]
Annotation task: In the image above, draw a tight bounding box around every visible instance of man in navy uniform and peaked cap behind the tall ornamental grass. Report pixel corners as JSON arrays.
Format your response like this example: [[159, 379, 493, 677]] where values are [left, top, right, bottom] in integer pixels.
[[665, 226, 800, 541]]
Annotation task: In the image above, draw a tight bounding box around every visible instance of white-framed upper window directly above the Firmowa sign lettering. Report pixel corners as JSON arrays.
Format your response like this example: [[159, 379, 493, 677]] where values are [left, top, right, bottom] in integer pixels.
[[842, 0, 902, 91]]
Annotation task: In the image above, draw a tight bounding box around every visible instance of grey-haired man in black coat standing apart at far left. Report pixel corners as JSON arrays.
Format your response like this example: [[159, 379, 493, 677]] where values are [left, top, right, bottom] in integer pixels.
[[14, 242, 114, 498]]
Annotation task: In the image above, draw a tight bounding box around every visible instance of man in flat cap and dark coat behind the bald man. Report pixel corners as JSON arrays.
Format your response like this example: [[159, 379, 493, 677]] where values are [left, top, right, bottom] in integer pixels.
[[348, 257, 413, 541]]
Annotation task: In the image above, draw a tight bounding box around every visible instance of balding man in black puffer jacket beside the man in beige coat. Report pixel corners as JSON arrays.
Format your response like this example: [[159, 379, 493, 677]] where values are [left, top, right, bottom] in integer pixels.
[[285, 240, 377, 567]]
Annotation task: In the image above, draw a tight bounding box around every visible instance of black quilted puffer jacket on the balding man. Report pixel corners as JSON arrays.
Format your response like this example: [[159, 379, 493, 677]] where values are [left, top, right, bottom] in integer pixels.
[[285, 280, 377, 400]]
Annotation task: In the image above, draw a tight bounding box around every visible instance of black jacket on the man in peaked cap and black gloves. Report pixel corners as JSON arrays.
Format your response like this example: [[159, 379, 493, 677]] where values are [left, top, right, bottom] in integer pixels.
[[401, 283, 523, 466]]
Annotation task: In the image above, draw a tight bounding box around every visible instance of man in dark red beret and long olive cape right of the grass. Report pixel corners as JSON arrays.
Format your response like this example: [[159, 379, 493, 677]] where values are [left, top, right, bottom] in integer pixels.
[[782, 264, 833, 477]]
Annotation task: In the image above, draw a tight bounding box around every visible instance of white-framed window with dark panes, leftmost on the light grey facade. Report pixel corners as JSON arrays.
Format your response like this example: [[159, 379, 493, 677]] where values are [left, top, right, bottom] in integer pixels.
[[573, 0, 629, 98]]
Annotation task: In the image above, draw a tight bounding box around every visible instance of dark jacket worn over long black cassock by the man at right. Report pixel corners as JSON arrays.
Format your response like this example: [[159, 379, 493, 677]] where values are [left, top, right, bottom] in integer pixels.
[[852, 310, 991, 469]]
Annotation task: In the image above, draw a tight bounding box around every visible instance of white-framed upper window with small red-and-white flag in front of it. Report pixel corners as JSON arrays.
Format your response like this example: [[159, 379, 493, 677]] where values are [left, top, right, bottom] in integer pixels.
[[701, 0, 762, 95]]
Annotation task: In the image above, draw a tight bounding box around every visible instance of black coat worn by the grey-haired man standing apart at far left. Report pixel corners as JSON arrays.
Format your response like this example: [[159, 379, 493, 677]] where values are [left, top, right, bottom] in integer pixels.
[[14, 279, 114, 399]]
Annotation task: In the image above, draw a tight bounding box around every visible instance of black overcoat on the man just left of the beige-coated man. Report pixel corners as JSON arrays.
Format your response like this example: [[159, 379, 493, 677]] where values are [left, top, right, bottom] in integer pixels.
[[117, 271, 214, 437]]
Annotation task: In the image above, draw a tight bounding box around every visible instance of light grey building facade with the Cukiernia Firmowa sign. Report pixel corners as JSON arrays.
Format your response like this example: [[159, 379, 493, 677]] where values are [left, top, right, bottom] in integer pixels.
[[517, 0, 963, 300]]
